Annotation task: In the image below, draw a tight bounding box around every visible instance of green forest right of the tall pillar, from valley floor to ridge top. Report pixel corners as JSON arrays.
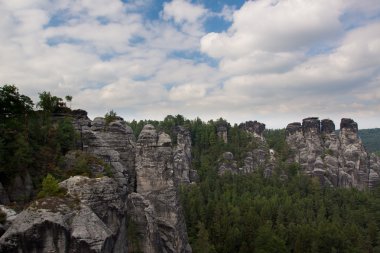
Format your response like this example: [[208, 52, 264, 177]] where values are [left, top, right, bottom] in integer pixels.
[[127, 116, 380, 253]]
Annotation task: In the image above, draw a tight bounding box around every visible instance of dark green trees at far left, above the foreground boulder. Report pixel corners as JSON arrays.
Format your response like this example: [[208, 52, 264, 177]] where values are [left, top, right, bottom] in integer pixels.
[[0, 85, 109, 204]]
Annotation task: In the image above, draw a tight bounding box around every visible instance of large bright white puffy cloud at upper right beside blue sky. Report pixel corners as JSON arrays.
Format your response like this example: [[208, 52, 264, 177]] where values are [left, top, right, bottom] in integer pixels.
[[201, 0, 341, 58]]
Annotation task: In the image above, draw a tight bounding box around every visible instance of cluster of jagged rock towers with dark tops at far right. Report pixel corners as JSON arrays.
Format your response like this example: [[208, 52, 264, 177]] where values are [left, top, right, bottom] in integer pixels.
[[286, 117, 380, 189]]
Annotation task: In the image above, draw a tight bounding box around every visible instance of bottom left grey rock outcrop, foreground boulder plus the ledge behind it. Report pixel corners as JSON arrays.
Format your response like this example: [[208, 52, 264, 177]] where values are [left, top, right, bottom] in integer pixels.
[[0, 176, 122, 253]]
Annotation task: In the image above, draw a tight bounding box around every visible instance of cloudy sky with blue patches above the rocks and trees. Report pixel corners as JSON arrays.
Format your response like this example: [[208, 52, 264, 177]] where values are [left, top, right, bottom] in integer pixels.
[[0, 0, 380, 128]]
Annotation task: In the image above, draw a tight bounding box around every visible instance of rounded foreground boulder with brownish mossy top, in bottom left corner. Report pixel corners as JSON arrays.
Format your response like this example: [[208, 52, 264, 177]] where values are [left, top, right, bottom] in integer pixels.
[[0, 198, 113, 253]]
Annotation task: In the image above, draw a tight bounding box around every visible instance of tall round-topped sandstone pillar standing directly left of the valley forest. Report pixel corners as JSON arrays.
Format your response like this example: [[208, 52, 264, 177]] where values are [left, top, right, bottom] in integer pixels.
[[136, 125, 191, 252]]
